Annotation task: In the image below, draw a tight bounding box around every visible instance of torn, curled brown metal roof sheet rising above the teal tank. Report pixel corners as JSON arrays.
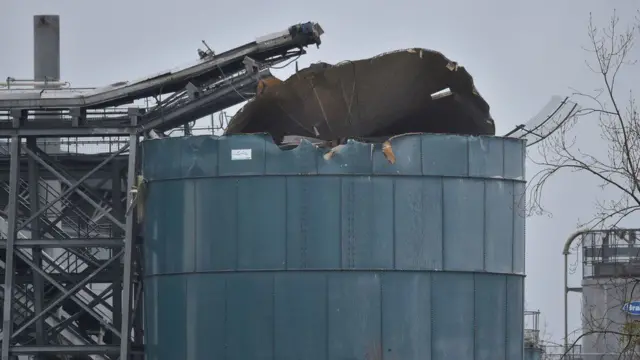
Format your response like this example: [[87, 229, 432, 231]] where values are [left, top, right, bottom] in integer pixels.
[[226, 49, 495, 143]]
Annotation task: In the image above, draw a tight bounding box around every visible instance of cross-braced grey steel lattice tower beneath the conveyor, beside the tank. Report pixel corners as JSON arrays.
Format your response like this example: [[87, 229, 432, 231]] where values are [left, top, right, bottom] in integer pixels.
[[0, 113, 142, 360]]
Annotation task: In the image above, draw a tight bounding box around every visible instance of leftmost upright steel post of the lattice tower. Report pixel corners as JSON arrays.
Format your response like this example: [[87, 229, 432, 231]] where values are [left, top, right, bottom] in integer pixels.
[[2, 136, 20, 360]]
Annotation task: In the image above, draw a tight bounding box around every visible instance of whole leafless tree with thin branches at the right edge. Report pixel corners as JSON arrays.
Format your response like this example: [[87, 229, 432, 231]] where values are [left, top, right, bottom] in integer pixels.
[[527, 12, 640, 359]]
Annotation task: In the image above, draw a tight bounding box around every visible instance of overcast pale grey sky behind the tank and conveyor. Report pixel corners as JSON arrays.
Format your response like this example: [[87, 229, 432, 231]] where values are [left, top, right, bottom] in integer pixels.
[[0, 0, 640, 346]]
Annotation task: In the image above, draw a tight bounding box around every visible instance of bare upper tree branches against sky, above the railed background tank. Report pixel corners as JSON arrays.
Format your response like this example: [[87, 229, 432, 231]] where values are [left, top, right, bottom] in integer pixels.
[[528, 12, 640, 228]]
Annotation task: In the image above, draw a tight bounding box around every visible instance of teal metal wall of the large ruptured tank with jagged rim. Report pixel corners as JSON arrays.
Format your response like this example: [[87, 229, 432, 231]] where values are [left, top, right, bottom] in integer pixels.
[[143, 134, 525, 360]]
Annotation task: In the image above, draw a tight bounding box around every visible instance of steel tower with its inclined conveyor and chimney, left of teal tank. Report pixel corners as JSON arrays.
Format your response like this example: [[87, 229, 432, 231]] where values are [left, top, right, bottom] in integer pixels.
[[0, 15, 323, 360]]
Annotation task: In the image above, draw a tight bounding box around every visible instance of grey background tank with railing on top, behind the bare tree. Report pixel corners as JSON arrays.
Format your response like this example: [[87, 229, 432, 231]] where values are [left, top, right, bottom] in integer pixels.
[[580, 229, 640, 360]]
